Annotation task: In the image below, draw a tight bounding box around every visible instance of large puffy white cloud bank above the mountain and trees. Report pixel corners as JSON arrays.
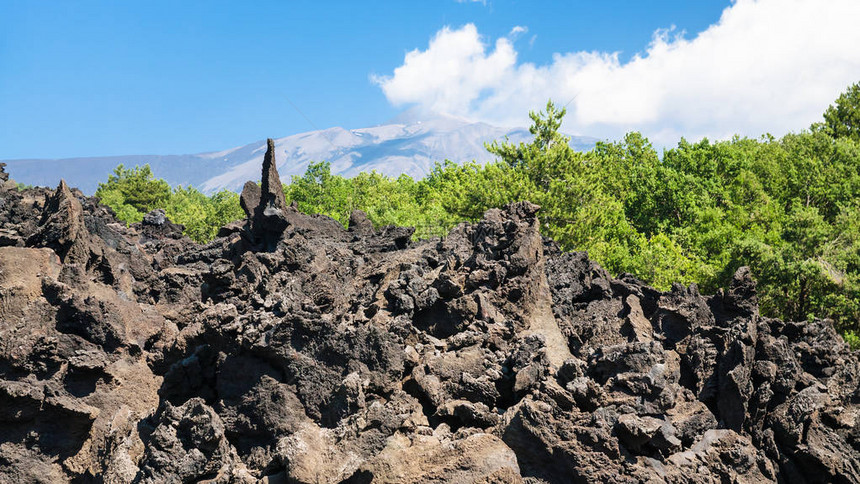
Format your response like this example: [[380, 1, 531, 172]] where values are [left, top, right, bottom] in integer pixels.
[[373, 0, 860, 145]]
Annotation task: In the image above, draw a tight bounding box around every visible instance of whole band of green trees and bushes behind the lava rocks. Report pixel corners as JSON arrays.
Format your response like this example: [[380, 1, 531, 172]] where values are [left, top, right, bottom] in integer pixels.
[[98, 84, 860, 347]]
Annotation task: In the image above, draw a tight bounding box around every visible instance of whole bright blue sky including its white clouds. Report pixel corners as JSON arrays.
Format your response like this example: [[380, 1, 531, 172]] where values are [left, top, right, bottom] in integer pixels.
[[0, 0, 860, 159]]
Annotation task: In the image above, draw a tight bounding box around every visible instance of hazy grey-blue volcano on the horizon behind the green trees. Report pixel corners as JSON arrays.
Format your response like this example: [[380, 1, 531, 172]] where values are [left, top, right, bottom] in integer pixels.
[[3, 111, 597, 194]]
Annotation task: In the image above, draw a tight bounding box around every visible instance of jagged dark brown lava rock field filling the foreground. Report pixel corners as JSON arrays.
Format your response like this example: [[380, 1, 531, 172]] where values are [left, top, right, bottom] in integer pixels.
[[0, 148, 860, 483]]
